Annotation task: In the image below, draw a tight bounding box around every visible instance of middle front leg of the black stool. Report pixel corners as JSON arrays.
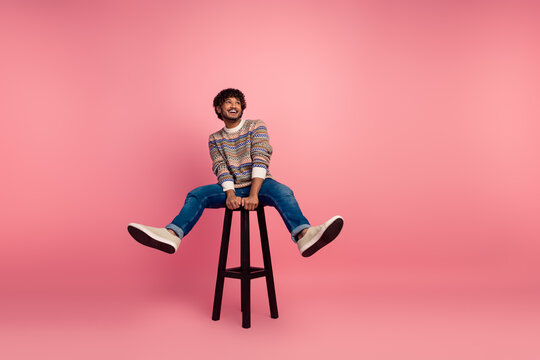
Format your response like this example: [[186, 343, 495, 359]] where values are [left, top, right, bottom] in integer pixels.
[[240, 208, 251, 328]]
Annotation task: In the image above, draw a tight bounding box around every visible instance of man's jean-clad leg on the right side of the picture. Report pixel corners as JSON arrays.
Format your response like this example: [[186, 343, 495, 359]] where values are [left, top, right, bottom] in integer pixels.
[[259, 178, 311, 243]]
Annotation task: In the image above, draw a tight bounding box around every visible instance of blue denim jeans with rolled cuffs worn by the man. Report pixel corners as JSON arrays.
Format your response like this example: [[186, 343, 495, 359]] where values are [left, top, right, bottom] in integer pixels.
[[165, 178, 310, 243]]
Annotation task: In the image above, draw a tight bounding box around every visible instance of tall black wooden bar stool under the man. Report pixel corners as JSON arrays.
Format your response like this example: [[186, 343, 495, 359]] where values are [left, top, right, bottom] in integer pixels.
[[212, 203, 278, 328]]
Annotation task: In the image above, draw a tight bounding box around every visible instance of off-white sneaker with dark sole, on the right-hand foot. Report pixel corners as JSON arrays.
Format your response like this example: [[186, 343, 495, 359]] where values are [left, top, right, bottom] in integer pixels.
[[296, 215, 343, 257]]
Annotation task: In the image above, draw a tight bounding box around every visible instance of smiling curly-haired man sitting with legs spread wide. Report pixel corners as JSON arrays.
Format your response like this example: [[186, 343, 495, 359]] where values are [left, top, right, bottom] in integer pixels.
[[128, 88, 343, 257]]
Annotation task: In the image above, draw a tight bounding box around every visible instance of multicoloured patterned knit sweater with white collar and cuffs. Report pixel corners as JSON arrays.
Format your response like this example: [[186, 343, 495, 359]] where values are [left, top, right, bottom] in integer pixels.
[[208, 119, 273, 191]]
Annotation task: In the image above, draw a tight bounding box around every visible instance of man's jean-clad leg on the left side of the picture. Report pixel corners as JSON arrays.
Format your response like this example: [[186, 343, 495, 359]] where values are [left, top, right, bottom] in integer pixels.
[[165, 184, 227, 238]]
